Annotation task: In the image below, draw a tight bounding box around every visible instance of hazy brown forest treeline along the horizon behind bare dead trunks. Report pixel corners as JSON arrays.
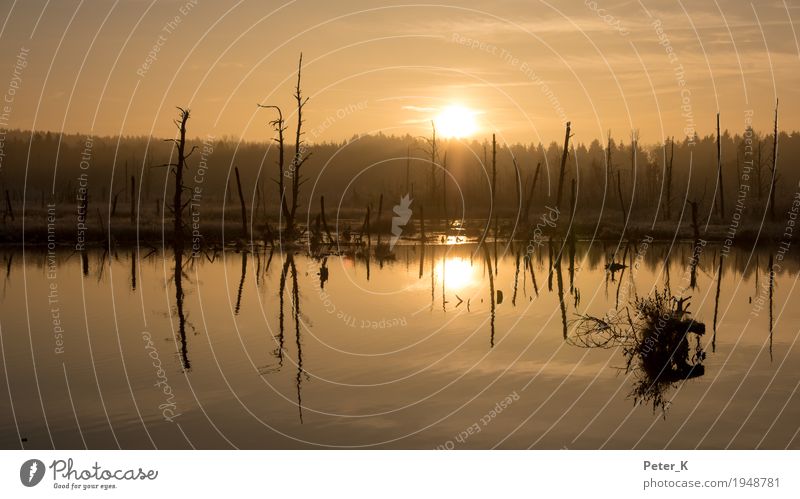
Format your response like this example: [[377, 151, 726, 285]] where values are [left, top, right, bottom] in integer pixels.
[[0, 126, 800, 225]]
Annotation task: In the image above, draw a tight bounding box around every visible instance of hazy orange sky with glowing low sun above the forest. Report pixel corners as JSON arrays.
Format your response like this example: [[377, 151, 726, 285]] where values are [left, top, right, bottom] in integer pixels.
[[0, 0, 800, 143]]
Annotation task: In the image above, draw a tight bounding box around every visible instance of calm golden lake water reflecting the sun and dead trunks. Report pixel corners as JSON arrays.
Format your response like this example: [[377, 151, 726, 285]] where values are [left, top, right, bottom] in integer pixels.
[[0, 241, 800, 449]]
